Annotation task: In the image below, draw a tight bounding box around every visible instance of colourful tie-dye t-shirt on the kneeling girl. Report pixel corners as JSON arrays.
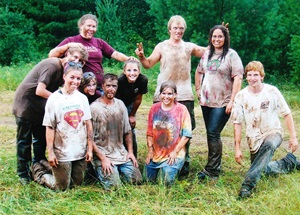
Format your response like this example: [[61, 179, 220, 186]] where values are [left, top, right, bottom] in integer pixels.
[[147, 102, 192, 162]]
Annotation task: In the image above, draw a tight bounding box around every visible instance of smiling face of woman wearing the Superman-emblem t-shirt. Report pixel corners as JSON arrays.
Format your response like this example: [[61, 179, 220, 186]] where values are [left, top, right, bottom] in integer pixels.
[[63, 68, 82, 93]]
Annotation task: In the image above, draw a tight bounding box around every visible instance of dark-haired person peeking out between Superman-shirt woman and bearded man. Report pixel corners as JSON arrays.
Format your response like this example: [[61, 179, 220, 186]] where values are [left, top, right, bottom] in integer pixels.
[[79, 72, 101, 184]]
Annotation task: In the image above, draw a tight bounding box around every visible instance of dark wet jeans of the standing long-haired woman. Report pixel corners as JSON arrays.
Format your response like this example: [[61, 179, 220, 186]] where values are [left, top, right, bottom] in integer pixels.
[[201, 106, 230, 177]]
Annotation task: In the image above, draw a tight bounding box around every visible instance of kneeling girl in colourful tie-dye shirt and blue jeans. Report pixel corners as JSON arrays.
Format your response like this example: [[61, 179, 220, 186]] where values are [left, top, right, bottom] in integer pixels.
[[145, 81, 192, 185]]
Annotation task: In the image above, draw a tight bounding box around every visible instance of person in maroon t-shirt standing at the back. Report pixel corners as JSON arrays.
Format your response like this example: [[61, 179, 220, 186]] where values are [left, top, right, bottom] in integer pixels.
[[49, 14, 129, 87]]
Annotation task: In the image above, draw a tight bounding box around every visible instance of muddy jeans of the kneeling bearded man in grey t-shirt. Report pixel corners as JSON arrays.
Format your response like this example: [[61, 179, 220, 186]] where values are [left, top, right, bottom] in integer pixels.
[[95, 161, 142, 190]]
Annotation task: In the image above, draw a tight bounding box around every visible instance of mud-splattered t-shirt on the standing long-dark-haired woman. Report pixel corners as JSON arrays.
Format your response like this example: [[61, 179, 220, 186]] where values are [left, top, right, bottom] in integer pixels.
[[197, 49, 244, 108]]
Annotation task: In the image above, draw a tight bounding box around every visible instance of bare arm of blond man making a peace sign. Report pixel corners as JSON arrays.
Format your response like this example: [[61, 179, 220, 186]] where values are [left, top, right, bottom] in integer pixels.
[[135, 43, 161, 69]]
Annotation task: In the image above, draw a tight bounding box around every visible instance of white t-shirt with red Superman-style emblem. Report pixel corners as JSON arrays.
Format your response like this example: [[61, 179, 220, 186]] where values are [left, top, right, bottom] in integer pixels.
[[43, 90, 91, 162]]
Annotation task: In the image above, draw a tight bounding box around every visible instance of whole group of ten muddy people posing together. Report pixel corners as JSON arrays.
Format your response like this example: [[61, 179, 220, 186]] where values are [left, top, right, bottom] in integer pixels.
[[13, 14, 300, 198]]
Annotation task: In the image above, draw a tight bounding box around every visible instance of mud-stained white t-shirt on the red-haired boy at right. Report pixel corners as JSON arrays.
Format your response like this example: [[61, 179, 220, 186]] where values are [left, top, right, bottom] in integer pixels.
[[232, 84, 291, 154]]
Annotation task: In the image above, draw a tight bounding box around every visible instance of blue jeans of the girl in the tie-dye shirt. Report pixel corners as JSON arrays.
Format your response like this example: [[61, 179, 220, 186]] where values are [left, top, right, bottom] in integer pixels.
[[145, 158, 185, 185]]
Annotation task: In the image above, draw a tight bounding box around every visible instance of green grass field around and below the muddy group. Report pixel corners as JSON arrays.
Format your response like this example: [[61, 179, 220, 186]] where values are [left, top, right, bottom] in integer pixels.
[[0, 63, 300, 215]]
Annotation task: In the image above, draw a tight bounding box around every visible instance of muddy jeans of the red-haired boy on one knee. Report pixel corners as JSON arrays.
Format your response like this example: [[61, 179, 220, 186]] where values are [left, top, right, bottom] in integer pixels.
[[242, 133, 284, 190]]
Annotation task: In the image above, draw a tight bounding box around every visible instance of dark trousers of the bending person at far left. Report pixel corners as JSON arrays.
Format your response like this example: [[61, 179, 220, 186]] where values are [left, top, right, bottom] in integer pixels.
[[16, 117, 46, 178]]
